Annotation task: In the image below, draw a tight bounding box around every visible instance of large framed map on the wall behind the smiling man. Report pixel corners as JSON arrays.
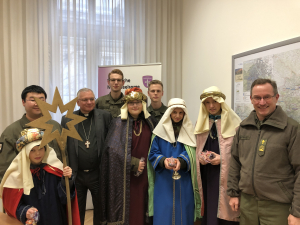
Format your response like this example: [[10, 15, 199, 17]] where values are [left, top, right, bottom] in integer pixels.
[[232, 37, 300, 122]]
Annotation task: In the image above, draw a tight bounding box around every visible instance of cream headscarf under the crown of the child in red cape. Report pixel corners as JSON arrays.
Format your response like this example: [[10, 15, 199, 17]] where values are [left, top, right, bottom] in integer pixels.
[[0, 140, 63, 198]]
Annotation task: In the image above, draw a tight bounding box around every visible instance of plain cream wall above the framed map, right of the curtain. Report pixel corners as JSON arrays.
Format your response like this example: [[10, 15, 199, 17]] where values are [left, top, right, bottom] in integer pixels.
[[182, 0, 300, 122]]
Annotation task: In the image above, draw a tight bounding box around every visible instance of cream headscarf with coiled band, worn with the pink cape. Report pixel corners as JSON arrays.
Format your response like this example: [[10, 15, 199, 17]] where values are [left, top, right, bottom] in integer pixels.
[[195, 86, 241, 138]]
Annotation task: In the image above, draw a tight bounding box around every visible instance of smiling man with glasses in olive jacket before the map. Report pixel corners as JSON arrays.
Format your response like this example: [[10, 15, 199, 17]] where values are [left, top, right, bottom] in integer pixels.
[[227, 79, 300, 225]]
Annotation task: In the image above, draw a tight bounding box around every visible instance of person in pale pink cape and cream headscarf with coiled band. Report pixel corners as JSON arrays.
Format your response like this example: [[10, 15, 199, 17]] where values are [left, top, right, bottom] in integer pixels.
[[195, 86, 241, 225]]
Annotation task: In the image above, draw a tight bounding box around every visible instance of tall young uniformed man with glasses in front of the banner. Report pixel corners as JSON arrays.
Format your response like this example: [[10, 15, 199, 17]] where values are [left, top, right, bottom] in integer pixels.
[[96, 69, 125, 118]]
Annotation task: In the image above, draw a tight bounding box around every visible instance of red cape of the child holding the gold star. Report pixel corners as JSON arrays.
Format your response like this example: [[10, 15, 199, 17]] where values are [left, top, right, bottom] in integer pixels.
[[2, 165, 80, 225]]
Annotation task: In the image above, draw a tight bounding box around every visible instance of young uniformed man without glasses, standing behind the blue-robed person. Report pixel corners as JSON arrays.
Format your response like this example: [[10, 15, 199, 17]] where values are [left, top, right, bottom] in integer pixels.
[[147, 80, 168, 123]]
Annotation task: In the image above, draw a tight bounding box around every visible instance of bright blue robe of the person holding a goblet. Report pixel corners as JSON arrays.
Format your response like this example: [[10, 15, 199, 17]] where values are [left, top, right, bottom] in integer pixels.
[[148, 136, 195, 225]]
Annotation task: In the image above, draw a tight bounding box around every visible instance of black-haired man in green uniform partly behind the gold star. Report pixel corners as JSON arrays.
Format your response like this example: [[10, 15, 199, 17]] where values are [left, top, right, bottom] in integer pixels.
[[0, 85, 62, 182]]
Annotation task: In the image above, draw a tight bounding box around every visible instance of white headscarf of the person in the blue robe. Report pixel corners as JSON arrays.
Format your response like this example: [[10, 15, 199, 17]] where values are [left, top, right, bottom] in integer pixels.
[[153, 98, 196, 147]]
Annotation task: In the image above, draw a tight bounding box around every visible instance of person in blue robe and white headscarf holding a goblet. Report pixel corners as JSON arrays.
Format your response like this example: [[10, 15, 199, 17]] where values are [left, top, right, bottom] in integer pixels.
[[147, 98, 201, 225]]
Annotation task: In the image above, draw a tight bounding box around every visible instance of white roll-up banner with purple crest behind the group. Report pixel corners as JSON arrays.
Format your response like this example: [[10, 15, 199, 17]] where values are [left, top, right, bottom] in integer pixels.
[[98, 63, 161, 100]]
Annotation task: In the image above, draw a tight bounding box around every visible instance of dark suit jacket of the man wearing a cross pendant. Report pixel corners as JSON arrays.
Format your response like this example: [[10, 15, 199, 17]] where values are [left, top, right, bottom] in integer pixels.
[[61, 109, 112, 178]]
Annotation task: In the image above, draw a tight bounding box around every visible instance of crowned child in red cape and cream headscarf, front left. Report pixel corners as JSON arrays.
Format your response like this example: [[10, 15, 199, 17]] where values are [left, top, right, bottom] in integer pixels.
[[0, 128, 80, 225]]
